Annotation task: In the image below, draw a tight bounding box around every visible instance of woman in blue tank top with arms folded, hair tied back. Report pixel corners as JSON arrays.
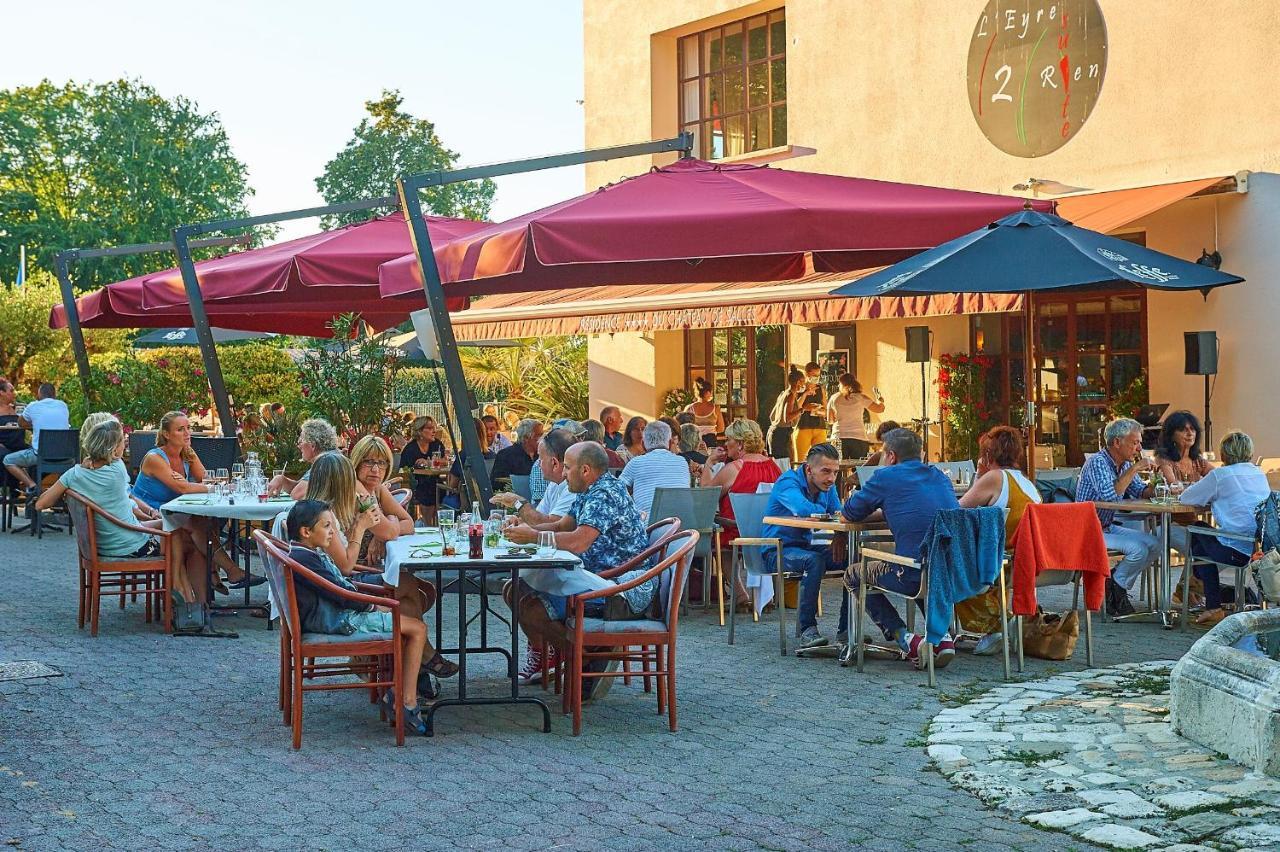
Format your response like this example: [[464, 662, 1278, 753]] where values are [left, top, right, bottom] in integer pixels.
[[133, 411, 266, 595]]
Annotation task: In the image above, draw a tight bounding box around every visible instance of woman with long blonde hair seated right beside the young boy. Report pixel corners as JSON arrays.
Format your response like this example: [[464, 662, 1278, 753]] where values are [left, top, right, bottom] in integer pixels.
[[306, 453, 458, 697]]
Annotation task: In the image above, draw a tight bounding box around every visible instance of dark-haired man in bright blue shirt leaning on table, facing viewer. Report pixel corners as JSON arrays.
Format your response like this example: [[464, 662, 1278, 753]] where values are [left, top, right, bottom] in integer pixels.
[[764, 444, 847, 649]]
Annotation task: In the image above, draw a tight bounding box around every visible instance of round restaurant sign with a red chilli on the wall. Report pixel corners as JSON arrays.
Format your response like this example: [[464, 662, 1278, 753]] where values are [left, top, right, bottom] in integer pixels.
[[969, 0, 1107, 157]]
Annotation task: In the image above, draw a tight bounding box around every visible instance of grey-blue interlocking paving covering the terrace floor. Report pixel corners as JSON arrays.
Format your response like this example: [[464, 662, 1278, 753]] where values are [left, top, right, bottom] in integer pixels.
[[0, 533, 1194, 849]]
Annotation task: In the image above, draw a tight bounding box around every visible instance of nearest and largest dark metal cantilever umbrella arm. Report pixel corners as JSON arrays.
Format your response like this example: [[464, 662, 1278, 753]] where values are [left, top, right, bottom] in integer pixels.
[[396, 133, 694, 505]]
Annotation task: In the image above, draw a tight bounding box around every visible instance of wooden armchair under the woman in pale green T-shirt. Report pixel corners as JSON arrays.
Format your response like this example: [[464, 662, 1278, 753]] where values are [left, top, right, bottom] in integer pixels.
[[65, 489, 179, 636]]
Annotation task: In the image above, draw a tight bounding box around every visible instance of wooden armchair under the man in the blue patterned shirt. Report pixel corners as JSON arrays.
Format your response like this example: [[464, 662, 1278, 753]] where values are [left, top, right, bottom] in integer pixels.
[[564, 530, 699, 737]]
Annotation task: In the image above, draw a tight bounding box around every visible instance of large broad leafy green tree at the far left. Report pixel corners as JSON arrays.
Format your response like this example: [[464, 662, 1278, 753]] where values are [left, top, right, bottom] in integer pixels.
[[0, 79, 252, 289]]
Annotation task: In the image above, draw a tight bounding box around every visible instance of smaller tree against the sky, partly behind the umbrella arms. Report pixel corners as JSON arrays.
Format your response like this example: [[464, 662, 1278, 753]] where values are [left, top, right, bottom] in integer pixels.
[[316, 90, 495, 228]]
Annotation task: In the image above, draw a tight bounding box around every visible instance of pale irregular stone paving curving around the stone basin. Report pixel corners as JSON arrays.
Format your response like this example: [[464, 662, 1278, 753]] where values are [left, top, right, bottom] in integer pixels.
[[928, 661, 1280, 852]]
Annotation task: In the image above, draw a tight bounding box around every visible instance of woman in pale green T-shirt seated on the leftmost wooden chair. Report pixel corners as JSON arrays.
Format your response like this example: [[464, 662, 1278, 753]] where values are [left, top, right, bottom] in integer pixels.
[[36, 414, 205, 604]]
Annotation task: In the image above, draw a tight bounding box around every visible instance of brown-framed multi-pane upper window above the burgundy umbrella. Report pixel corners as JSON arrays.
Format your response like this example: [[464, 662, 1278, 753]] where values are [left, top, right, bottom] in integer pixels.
[[676, 9, 787, 160]]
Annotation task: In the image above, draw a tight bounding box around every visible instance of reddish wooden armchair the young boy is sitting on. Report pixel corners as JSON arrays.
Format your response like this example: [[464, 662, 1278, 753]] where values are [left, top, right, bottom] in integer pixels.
[[253, 530, 404, 750]]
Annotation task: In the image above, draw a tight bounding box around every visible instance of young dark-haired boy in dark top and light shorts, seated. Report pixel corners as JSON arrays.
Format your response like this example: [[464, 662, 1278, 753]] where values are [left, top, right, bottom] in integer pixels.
[[285, 500, 426, 736]]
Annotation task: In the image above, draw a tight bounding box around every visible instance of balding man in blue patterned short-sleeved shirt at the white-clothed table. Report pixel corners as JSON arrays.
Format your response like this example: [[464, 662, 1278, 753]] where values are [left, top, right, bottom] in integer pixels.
[[507, 441, 658, 697]]
